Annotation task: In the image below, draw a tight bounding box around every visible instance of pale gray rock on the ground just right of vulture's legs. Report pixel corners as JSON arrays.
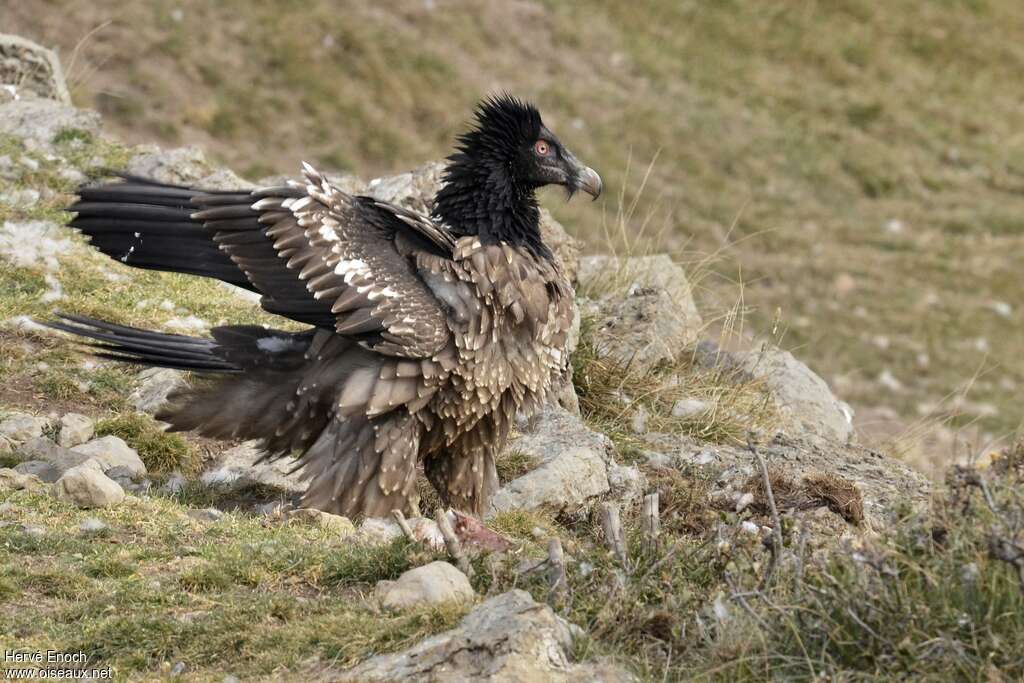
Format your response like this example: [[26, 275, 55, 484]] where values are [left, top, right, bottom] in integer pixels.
[[490, 404, 611, 513]]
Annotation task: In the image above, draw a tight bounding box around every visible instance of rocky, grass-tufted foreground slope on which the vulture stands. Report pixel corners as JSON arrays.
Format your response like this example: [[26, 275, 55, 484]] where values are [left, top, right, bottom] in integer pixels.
[[0, 36, 1024, 681]]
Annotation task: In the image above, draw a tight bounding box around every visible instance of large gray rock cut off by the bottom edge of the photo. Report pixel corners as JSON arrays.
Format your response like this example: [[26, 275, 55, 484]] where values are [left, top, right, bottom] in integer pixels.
[[333, 590, 635, 683]]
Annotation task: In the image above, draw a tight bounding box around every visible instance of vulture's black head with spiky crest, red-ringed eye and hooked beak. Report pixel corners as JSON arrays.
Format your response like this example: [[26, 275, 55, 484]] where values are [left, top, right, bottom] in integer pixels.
[[451, 94, 601, 199]]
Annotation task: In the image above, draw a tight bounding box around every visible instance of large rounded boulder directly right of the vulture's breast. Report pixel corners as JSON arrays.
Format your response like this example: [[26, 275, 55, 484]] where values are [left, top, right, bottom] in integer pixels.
[[579, 254, 703, 372]]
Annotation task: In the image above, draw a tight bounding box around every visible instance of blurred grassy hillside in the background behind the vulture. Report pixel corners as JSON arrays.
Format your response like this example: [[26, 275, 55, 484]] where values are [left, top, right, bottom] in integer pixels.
[[8, 0, 1024, 464]]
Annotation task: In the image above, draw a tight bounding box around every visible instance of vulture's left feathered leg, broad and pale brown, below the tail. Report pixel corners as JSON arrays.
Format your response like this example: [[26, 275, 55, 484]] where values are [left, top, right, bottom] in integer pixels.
[[302, 411, 423, 517]]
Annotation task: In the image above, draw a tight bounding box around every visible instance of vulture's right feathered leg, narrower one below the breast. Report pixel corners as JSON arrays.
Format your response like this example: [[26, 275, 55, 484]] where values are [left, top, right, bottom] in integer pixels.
[[424, 442, 499, 517]]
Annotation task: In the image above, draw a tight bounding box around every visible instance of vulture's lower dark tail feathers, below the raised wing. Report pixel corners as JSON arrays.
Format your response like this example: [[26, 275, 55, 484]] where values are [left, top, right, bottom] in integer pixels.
[[40, 314, 339, 457]]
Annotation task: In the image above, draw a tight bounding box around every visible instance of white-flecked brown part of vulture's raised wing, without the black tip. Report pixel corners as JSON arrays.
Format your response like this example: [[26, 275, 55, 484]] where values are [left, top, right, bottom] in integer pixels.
[[193, 165, 454, 358]]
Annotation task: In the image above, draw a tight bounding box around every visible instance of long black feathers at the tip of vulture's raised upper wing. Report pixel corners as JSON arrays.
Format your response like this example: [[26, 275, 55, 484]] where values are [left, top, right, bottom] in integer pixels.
[[68, 176, 255, 291]]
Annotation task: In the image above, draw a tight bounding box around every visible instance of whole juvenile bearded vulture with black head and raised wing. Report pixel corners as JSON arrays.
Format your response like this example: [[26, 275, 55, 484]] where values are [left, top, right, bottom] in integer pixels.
[[52, 95, 601, 516]]
